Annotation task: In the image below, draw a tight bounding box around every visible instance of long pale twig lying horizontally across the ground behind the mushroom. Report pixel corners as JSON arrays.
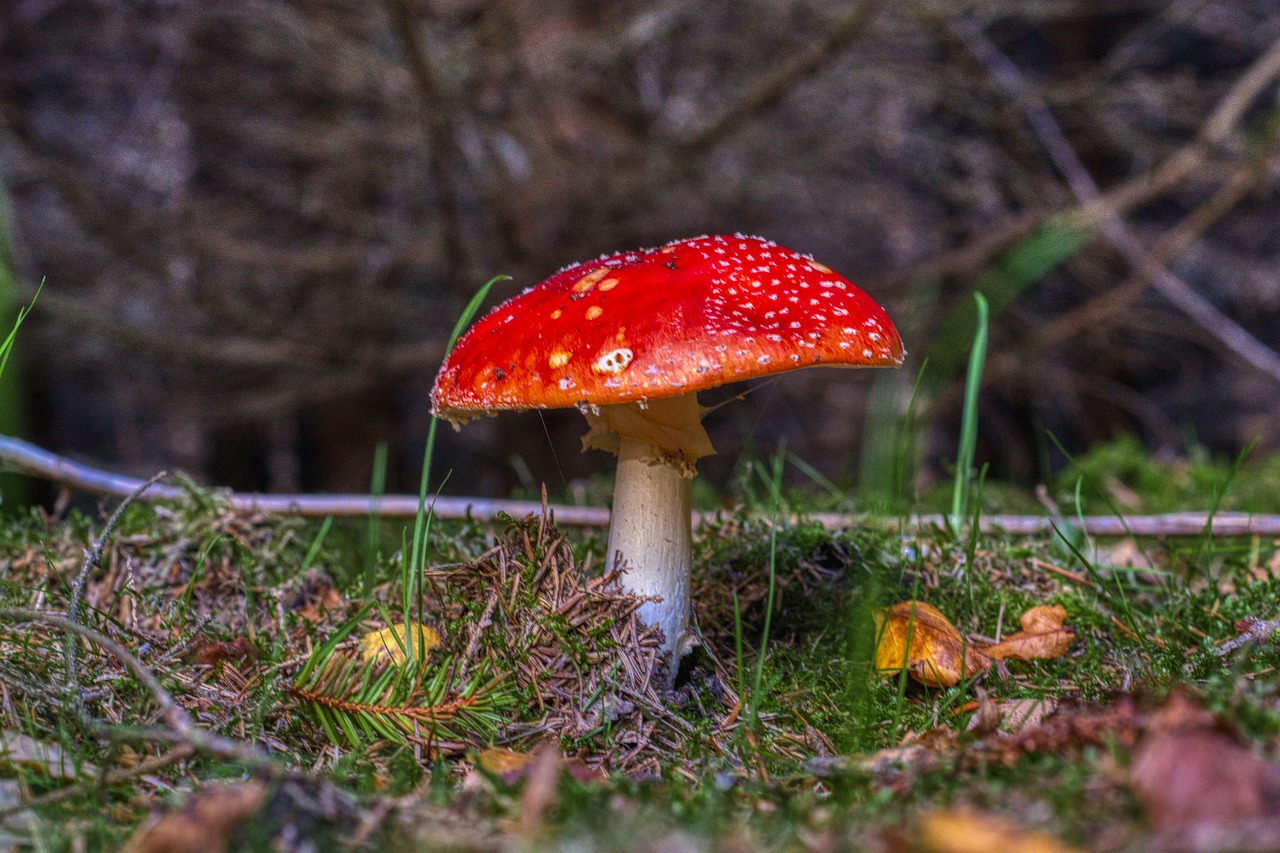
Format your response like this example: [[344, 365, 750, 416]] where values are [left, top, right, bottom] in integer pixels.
[[0, 435, 1280, 537]]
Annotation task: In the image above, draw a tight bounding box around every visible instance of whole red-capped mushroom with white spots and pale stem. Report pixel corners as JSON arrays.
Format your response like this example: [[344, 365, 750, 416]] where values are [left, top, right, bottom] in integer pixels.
[[431, 234, 902, 679]]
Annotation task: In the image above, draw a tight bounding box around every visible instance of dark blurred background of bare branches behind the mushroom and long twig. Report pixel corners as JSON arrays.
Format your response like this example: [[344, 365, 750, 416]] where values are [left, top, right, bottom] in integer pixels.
[[0, 0, 1280, 494]]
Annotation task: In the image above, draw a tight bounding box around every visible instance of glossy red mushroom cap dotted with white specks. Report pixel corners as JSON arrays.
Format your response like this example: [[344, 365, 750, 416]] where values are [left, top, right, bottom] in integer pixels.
[[431, 234, 902, 420]]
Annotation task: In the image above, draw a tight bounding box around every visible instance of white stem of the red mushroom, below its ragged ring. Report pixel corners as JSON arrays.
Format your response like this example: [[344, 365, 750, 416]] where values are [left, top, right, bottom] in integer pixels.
[[608, 438, 692, 679]]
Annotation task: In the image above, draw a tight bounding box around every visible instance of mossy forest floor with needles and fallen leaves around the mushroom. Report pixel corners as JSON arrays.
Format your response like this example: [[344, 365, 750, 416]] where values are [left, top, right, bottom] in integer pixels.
[[0, 442, 1280, 853]]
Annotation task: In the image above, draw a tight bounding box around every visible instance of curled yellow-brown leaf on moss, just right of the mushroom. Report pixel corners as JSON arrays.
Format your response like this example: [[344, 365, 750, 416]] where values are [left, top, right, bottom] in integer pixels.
[[876, 601, 991, 686]]
